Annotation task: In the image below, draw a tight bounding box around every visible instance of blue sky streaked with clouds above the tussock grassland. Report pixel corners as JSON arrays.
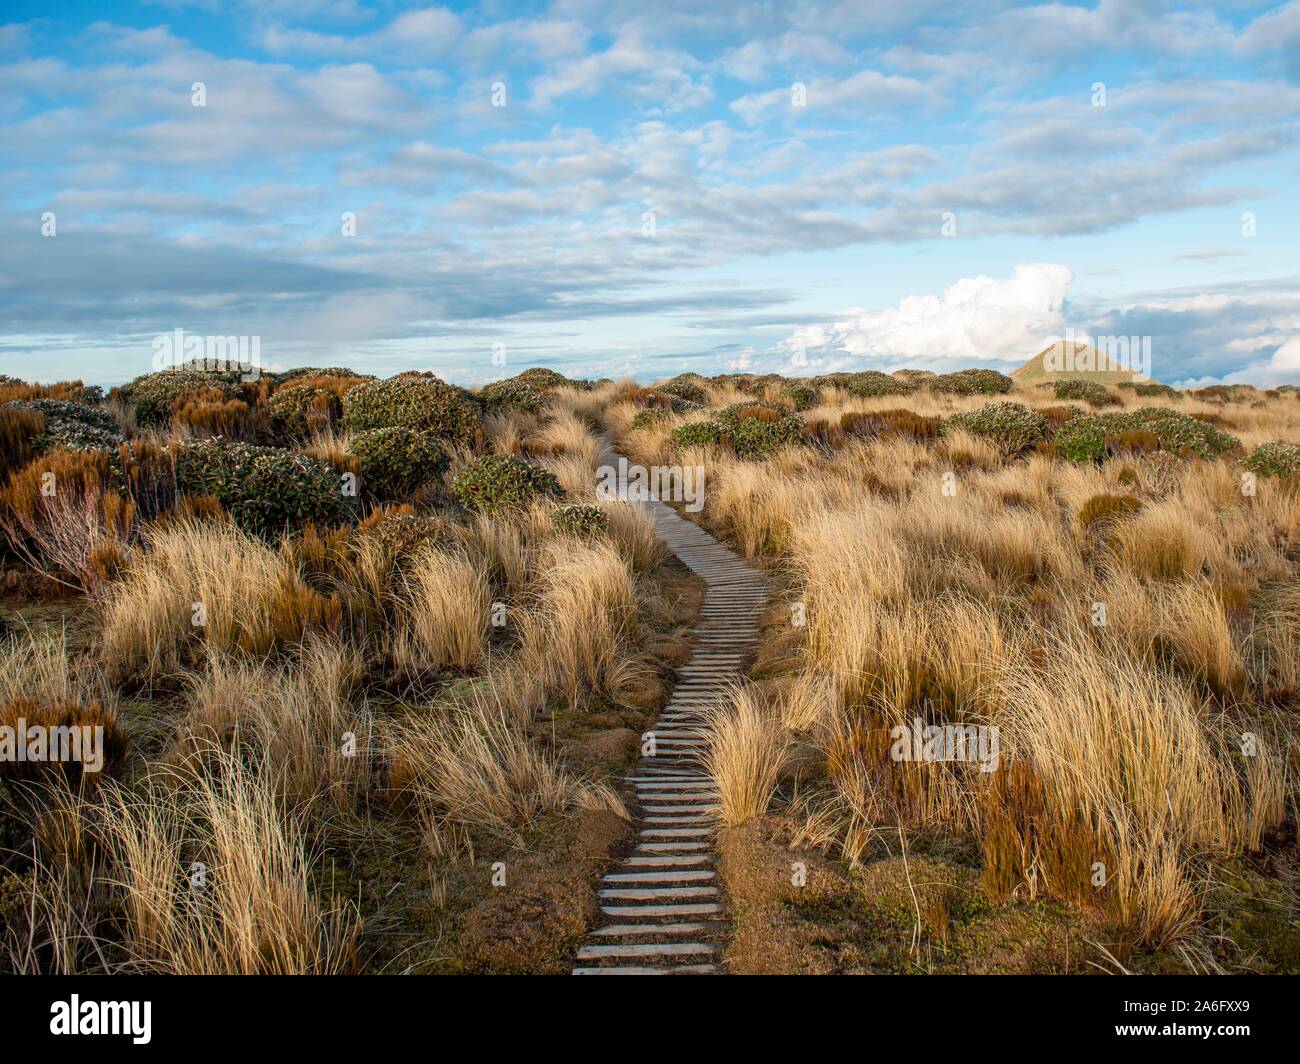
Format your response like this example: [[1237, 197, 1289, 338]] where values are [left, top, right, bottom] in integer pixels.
[[0, 0, 1300, 384]]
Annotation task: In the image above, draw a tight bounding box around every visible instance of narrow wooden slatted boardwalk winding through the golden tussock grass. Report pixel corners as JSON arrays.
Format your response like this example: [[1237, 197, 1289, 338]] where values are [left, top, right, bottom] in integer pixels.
[[573, 483, 767, 976]]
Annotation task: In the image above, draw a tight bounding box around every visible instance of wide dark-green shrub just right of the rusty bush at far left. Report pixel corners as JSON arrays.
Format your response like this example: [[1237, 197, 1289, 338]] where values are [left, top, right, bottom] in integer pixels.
[[176, 438, 352, 536]]
